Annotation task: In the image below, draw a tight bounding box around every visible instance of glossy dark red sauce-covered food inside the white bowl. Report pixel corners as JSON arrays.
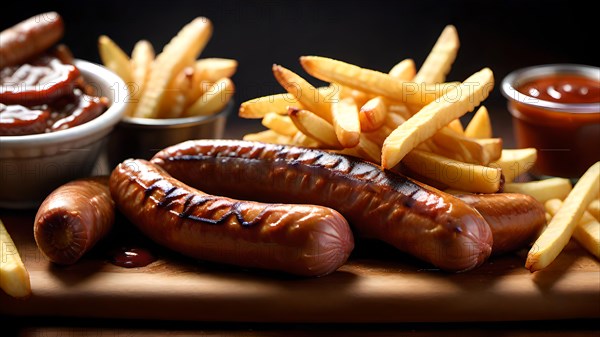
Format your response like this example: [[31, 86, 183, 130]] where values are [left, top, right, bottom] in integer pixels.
[[0, 54, 108, 136]]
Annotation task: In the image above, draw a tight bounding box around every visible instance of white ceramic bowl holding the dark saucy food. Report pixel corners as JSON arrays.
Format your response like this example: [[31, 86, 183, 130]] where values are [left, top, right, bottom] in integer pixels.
[[0, 60, 127, 208]]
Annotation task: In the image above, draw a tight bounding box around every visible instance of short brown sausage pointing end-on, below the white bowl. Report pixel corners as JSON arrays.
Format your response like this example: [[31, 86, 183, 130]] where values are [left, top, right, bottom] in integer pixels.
[[33, 177, 115, 264]]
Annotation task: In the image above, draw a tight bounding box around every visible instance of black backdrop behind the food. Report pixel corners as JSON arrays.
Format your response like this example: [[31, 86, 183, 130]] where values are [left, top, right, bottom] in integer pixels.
[[0, 0, 600, 144]]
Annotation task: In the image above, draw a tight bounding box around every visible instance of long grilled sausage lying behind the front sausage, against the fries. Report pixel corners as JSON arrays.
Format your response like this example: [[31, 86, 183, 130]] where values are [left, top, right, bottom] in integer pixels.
[[152, 140, 492, 271]]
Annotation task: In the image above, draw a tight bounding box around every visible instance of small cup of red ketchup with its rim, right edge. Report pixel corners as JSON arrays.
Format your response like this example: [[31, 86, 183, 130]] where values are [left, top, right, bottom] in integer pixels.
[[502, 64, 600, 179]]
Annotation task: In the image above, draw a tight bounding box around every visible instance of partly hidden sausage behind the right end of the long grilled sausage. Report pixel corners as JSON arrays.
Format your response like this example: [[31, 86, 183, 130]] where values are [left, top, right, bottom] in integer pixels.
[[457, 193, 546, 255]]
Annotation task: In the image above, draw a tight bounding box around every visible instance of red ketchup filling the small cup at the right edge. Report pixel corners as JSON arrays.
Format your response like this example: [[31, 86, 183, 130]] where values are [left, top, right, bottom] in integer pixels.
[[510, 74, 600, 178]]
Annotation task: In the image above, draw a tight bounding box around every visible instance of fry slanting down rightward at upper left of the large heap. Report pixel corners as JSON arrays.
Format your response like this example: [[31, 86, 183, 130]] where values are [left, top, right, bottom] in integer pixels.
[[273, 64, 332, 123]]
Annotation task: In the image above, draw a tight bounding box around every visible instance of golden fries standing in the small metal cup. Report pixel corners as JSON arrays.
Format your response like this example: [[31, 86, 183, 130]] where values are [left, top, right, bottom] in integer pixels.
[[98, 17, 237, 118]]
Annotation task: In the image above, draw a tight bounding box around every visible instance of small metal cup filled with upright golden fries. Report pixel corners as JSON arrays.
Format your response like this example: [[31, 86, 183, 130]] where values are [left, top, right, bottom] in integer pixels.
[[98, 17, 237, 166]]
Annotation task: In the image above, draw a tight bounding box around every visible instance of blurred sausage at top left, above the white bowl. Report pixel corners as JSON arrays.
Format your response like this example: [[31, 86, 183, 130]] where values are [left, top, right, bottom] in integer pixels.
[[0, 12, 64, 68]]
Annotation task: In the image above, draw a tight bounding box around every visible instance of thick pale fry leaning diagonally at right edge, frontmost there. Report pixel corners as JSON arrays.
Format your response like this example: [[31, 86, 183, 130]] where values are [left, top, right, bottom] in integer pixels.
[[525, 162, 600, 272]]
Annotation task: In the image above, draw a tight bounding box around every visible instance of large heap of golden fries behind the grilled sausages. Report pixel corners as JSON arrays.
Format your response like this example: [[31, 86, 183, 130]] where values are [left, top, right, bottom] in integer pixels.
[[239, 25, 598, 270]]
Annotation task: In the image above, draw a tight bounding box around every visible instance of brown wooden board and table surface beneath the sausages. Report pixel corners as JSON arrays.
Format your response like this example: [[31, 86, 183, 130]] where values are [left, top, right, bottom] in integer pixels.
[[0, 112, 600, 336]]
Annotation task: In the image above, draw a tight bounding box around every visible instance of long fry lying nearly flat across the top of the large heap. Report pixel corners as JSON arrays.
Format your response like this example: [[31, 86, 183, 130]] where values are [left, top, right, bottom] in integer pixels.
[[300, 56, 458, 106]]
